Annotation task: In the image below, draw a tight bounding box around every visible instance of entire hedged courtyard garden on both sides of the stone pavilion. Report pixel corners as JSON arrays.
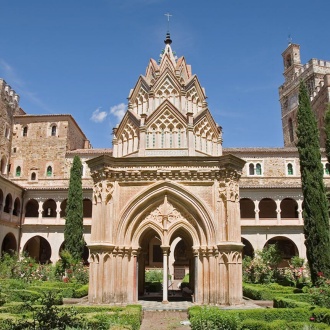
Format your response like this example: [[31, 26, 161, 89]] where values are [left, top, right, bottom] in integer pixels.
[[0, 246, 330, 330]]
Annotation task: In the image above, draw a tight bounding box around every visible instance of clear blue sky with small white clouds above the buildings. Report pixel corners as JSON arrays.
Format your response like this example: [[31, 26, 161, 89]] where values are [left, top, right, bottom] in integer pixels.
[[0, 0, 330, 148]]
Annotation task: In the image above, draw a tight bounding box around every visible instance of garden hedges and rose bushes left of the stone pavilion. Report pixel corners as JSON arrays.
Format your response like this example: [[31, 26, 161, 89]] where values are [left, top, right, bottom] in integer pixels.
[[0, 252, 142, 330]]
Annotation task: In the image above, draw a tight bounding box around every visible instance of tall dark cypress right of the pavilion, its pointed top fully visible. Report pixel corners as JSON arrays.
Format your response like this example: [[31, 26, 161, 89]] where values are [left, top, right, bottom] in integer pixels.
[[297, 82, 330, 285]]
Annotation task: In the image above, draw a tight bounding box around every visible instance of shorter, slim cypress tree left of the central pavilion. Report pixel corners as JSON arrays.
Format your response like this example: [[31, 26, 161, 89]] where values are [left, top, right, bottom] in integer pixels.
[[64, 156, 85, 261]]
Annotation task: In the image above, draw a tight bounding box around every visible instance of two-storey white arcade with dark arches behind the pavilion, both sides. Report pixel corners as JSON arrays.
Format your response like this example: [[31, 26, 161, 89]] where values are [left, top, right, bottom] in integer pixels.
[[0, 189, 305, 262]]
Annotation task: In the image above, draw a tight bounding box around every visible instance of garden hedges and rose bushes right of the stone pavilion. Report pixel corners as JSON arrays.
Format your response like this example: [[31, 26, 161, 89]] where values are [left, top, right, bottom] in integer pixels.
[[188, 245, 330, 330]]
